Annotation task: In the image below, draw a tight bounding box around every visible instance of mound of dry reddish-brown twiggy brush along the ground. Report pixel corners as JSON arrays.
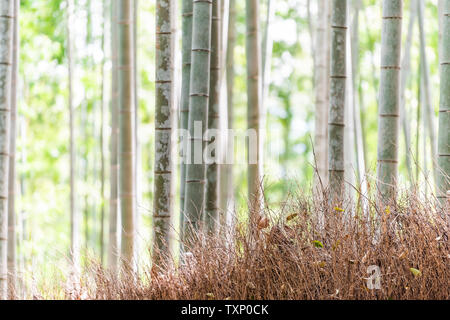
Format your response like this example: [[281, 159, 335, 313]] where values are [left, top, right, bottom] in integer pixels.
[[16, 186, 450, 300]]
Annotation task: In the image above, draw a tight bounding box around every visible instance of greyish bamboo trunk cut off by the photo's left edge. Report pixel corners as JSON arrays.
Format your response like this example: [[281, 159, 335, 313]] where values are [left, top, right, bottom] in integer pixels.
[[0, 0, 14, 300]]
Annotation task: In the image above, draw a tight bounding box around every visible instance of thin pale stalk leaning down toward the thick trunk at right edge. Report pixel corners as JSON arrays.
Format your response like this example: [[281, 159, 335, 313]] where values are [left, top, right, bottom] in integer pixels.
[[418, 1, 437, 188]]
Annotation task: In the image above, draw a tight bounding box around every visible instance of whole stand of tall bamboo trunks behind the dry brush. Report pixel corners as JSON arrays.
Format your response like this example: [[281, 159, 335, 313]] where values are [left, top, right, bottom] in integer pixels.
[[0, 0, 450, 298]]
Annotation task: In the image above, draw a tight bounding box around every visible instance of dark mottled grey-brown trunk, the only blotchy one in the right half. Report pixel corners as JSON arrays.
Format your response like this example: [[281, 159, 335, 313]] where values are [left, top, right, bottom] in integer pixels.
[[328, 0, 347, 205]]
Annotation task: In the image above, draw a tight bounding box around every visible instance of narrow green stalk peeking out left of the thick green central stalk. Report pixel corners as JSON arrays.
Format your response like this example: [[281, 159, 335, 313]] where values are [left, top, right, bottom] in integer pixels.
[[180, 0, 193, 239]]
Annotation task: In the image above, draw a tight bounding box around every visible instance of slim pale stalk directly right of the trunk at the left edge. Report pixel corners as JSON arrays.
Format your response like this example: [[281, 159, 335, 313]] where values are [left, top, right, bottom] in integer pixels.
[[8, 0, 20, 299]]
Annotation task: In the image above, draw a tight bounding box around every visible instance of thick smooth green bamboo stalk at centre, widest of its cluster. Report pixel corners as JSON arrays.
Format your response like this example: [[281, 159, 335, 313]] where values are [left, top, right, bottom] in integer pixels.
[[184, 1, 212, 245]]
